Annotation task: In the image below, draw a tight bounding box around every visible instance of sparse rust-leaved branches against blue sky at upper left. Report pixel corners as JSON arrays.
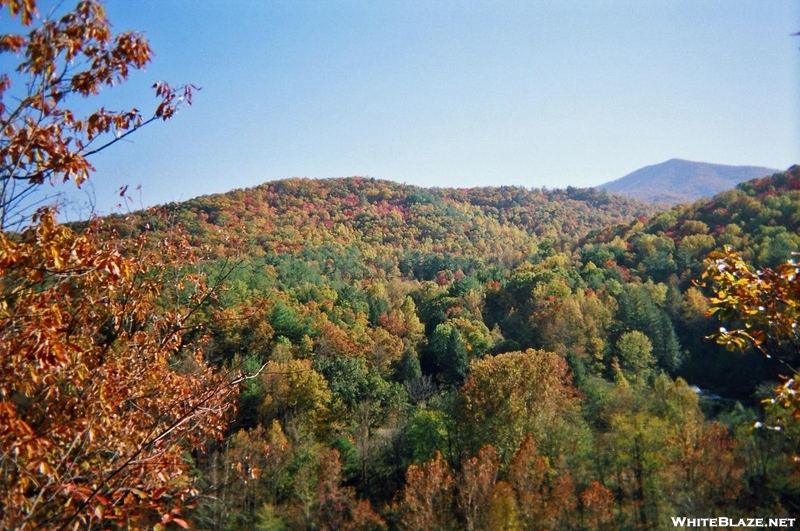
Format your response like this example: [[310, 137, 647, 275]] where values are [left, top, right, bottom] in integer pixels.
[[0, 0, 194, 229]]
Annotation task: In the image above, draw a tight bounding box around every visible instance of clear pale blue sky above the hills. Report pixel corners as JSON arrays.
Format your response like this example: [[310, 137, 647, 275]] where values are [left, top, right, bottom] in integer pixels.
[[18, 0, 800, 218]]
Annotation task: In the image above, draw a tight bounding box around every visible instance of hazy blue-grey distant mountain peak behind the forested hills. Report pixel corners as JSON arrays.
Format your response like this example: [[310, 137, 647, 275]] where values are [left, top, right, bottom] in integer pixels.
[[597, 159, 780, 205]]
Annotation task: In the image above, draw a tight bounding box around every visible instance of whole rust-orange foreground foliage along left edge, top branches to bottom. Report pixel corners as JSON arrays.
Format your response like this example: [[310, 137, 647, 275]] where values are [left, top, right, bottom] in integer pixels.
[[0, 0, 236, 529]]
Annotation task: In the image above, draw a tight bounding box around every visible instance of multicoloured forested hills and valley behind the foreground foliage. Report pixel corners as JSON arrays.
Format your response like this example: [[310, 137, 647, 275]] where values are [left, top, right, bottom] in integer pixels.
[[103, 167, 800, 529]]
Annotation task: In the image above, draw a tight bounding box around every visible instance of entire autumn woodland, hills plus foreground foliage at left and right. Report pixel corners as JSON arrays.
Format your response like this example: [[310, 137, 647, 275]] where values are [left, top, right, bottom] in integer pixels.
[[0, 0, 800, 531]]
